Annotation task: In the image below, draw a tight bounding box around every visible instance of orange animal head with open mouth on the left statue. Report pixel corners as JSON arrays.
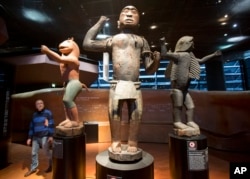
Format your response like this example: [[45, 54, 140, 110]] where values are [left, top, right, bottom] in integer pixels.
[[59, 37, 80, 56]]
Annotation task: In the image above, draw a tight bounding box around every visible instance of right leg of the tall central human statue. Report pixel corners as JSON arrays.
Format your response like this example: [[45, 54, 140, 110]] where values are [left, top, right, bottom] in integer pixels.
[[127, 90, 143, 152]]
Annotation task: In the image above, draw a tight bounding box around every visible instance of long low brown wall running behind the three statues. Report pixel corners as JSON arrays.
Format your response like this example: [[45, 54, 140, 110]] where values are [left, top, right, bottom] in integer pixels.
[[10, 88, 250, 152]]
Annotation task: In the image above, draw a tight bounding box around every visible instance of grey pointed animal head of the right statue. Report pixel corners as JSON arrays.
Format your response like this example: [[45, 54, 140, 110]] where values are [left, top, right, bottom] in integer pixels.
[[175, 36, 194, 52]]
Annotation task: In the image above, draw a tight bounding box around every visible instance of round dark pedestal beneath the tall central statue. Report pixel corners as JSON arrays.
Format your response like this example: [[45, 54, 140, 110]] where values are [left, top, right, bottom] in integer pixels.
[[96, 150, 154, 179]]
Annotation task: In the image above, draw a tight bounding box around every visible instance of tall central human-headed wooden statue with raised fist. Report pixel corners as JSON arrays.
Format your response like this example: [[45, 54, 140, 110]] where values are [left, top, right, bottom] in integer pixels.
[[83, 5, 160, 153]]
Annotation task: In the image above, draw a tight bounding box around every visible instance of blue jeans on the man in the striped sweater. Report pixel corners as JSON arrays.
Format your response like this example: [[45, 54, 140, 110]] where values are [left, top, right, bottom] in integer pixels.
[[30, 137, 52, 170]]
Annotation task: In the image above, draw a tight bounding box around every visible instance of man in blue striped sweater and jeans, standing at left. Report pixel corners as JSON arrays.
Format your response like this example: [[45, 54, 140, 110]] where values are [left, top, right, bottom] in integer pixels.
[[24, 99, 54, 177]]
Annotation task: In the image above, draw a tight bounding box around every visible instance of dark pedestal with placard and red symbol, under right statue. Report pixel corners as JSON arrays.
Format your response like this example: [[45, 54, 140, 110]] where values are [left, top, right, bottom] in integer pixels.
[[169, 134, 209, 179]]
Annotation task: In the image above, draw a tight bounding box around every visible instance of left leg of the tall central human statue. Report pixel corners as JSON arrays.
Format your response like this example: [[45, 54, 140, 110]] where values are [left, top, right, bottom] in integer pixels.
[[109, 88, 122, 152]]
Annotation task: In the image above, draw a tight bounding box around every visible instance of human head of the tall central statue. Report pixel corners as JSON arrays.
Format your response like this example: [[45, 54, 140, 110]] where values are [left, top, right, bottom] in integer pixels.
[[117, 5, 140, 30]]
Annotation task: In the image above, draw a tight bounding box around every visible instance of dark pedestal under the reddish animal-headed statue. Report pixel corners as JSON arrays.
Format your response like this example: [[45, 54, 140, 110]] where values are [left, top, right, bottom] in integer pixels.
[[53, 133, 86, 179]]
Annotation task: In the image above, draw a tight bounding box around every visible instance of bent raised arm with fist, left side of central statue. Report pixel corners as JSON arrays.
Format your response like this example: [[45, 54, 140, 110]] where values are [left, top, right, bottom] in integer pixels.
[[82, 16, 109, 52]]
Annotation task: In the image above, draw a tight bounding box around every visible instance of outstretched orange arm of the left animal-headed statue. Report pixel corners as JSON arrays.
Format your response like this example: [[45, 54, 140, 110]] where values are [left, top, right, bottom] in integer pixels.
[[41, 45, 79, 65]]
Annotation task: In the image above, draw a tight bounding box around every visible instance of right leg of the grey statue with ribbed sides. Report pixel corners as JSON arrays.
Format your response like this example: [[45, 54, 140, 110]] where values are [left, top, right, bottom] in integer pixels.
[[184, 93, 199, 129]]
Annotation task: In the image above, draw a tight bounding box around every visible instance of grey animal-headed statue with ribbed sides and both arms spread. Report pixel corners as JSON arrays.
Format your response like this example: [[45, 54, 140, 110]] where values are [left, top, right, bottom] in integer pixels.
[[160, 36, 221, 136]]
